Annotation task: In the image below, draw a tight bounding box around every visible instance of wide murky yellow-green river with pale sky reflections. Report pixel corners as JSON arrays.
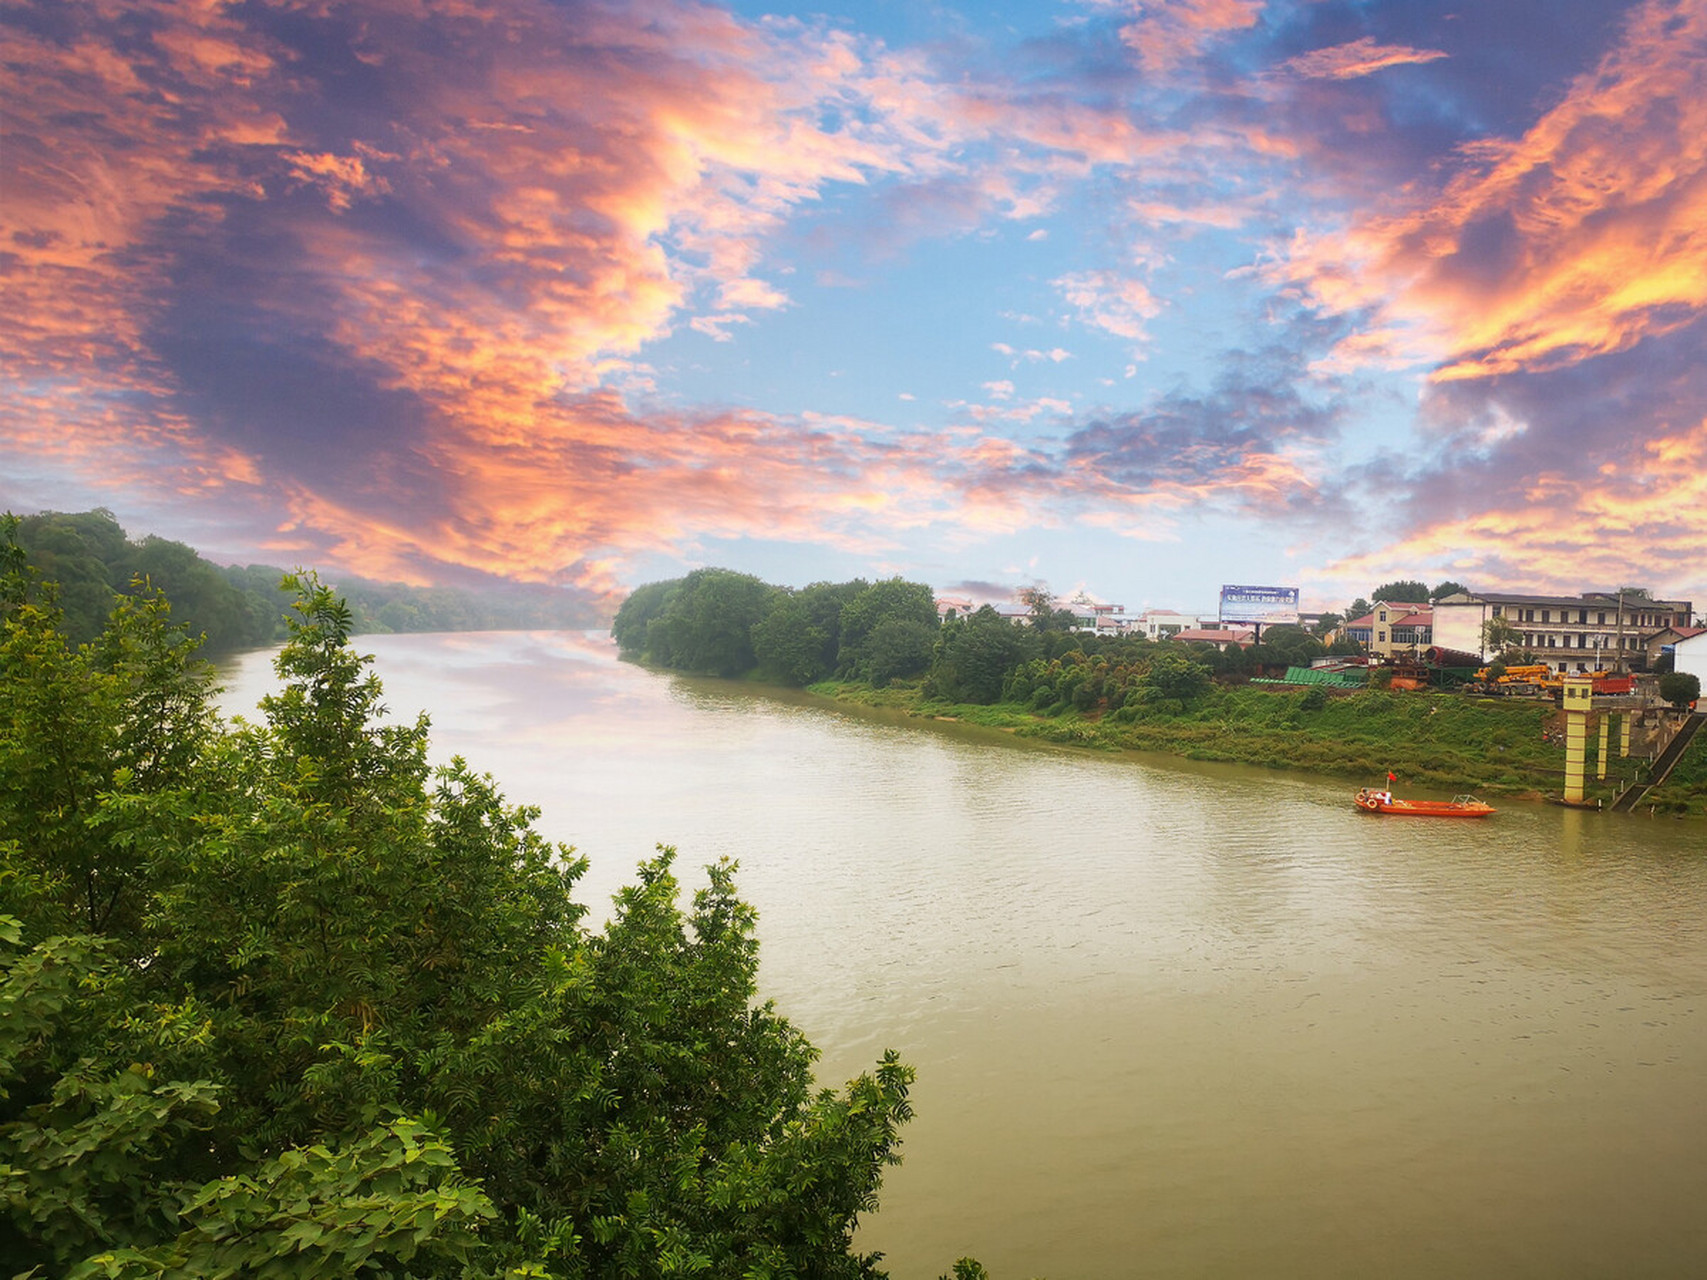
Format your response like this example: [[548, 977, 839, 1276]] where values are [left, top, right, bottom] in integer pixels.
[[222, 631, 1707, 1280]]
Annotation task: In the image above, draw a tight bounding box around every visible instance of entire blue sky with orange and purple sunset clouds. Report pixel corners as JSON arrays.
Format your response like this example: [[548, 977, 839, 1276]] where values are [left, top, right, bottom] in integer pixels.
[[0, 0, 1707, 611]]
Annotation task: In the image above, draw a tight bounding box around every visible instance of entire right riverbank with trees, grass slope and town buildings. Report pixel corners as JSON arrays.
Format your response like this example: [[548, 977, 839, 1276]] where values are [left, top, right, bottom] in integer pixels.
[[611, 568, 1707, 817]]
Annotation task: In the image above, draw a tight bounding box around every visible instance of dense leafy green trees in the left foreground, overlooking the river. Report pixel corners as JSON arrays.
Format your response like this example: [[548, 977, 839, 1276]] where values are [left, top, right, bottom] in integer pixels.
[[0, 531, 935, 1278]]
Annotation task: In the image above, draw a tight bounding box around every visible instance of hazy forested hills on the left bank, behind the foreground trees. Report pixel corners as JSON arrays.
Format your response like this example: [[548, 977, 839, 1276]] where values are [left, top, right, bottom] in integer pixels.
[[6, 509, 608, 654]]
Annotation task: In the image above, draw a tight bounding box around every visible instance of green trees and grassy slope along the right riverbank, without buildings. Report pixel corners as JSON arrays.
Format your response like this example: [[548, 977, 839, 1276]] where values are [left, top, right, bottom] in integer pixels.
[[613, 568, 1707, 817]]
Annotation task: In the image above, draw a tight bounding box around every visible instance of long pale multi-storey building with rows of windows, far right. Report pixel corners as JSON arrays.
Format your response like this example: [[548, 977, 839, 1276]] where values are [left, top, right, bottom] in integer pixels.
[[1434, 591, 1695, 672]]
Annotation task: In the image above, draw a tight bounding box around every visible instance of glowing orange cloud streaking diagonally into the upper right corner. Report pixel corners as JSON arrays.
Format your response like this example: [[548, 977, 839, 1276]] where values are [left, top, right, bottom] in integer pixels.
[[1272, 0, 1707, 381]]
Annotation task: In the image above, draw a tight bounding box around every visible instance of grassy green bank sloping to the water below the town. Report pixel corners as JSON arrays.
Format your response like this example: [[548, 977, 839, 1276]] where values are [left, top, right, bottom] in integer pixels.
[[811, 681, 1707, 817]]
